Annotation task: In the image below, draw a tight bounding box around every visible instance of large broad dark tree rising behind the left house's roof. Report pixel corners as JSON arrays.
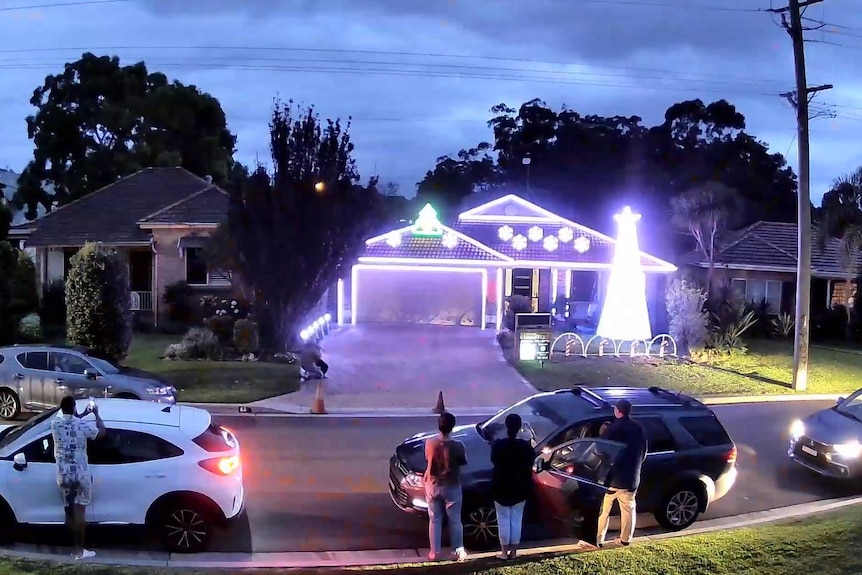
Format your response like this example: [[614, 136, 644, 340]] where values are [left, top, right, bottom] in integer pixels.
[[15, 53, 236, 218]]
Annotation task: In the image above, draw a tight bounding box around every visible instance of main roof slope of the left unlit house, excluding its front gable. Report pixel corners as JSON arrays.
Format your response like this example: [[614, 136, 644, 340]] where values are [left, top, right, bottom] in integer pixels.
[[27, 168, 212, 247]]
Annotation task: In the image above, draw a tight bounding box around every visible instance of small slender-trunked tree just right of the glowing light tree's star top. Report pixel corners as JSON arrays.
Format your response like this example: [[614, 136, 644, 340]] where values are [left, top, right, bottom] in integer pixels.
[[671, 182, 741, 294]]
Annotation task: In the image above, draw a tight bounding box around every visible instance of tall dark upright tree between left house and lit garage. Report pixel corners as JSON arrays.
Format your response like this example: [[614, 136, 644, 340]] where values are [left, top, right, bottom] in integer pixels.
[[221, 100, 380, 351]]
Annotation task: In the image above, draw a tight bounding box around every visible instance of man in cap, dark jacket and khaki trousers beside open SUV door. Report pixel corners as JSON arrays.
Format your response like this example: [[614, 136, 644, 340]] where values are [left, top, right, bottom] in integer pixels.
[[596, 399, 647, 547]]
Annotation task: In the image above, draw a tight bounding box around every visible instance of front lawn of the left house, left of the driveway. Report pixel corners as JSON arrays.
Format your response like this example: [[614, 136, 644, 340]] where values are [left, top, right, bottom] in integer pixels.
[[122, 334, 299, 404]]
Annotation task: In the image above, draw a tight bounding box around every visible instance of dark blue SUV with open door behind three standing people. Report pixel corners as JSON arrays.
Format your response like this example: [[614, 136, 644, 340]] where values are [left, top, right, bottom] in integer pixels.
[[389, 386, 737, 549]]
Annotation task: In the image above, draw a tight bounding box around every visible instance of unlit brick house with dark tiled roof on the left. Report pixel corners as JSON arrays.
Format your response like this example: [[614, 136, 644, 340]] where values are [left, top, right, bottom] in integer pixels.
[[13, 168, 233, 325]]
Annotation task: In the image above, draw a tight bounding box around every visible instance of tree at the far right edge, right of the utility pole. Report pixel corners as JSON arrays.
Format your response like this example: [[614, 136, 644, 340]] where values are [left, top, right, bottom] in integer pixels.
[[816, 167, 862, 330]]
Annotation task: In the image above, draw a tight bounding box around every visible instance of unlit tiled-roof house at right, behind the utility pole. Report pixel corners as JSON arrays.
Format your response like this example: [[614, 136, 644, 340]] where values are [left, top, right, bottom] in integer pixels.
[[680, 221, 862, 314]]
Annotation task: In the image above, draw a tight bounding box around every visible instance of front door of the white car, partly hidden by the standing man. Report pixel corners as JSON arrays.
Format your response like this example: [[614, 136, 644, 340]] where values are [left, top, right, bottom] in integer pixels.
[[2, 433, 92, 525]]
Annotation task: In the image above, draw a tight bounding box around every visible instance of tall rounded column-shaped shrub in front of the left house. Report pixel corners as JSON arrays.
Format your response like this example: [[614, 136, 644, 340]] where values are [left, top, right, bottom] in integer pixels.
[[66, 243, 132, 361]]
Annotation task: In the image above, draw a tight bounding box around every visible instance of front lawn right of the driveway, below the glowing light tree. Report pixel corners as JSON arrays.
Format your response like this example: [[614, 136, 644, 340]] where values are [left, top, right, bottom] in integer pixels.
[[507, 340, 862, 396]]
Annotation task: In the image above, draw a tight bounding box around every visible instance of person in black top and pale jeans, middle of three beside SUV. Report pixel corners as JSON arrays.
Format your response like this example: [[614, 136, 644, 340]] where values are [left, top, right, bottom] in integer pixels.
[[491, 413, 536, 560]]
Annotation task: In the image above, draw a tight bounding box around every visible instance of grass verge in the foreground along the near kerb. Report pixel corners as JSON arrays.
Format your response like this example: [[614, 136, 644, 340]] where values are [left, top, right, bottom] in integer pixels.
[[5, 507, 862, 575]]
